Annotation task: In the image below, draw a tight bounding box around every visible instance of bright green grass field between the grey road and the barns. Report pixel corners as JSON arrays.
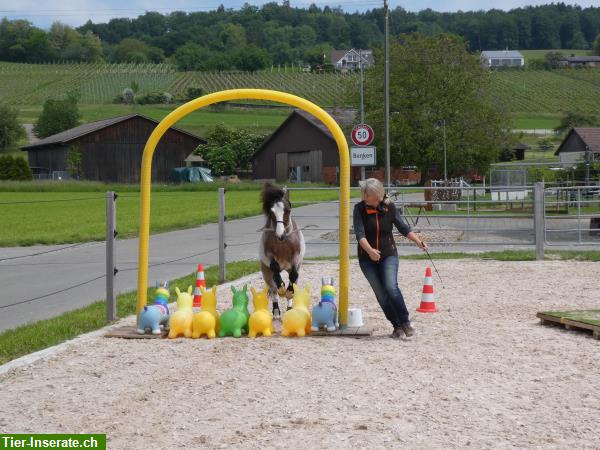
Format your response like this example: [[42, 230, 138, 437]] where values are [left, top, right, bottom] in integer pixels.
[[0, 186, 350, 247]]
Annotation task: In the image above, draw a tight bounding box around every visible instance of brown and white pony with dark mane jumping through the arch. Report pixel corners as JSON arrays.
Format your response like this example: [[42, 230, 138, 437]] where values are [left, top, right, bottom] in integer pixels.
[[259, 182, 306, 319]]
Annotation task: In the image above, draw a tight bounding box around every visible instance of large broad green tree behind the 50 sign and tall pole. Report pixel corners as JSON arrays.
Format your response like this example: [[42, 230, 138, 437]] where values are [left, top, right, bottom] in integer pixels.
[[365, 34, 510, 176]]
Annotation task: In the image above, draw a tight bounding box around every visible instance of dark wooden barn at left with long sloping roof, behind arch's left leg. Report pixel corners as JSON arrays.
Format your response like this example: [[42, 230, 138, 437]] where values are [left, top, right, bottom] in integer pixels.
[[21, 114, 206, 183]]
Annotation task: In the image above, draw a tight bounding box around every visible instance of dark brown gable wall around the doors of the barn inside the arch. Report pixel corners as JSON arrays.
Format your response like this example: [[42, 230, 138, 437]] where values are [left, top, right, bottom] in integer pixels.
[[252, 115, 340, 181]]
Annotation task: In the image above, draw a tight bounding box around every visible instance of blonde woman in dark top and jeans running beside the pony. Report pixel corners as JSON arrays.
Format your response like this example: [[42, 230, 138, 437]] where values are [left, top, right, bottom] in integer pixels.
[[353, 178, 427, 338]]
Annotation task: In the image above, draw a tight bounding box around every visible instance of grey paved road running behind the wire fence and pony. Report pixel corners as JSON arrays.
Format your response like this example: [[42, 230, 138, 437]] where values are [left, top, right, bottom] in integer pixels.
[[0, 194, 597, 331]]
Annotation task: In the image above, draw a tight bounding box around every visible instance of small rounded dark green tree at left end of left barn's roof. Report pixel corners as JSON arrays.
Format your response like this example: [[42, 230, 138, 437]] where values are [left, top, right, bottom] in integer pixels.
[[33, 95, 81, 139]]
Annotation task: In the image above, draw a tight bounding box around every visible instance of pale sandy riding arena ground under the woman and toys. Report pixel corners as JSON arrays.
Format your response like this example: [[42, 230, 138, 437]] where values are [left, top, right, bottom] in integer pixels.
[[0, 260, 600, 449]]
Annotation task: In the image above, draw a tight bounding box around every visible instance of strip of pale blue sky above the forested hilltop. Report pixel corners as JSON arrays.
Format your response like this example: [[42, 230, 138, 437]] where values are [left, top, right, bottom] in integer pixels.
[[0, 0, 600, 28]]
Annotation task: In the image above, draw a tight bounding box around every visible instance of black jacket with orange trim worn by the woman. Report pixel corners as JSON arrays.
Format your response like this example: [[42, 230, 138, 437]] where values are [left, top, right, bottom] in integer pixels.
[[353, 201, 411, 261]]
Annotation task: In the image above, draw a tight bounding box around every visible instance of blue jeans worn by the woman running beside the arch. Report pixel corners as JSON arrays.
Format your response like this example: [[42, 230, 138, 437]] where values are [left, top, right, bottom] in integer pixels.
[[359, 256, 409, 328]]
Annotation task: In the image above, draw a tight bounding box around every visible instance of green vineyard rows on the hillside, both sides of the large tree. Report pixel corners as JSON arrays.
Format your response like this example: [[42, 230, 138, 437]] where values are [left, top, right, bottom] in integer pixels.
[[0, 62, 600, 114]]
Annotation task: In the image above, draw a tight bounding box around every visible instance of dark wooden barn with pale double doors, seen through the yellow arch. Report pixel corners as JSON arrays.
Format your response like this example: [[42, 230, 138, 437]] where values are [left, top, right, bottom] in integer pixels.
[[252, 110, 354, 183]]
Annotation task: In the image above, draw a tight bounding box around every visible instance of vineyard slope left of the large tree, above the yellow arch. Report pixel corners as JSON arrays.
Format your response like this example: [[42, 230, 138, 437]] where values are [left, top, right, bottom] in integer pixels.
[[0, 62, 357, 106]]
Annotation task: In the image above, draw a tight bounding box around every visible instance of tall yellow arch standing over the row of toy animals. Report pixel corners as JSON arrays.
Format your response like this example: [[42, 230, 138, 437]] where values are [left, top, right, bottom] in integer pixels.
[[136, 89, 350, 326]]
